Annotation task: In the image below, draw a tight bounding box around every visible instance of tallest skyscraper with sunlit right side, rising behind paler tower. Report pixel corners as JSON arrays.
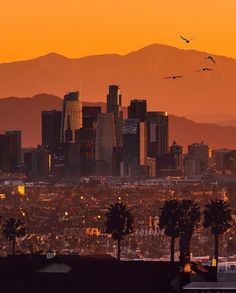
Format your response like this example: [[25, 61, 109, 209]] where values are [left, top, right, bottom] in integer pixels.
[[107, 85, 123, 147]]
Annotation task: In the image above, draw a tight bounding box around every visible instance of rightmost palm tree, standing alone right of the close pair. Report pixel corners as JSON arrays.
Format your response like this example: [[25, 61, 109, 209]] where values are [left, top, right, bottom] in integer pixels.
[[203, 199, 232, 263]]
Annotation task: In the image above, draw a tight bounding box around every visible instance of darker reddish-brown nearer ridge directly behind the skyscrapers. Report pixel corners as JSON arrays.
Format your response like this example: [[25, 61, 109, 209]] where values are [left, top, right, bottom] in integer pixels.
[[0, 94, 236, 149]]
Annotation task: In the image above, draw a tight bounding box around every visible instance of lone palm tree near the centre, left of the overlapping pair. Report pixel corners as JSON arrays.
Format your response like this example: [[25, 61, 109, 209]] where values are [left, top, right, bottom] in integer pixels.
[[105, 203, 133, 260]]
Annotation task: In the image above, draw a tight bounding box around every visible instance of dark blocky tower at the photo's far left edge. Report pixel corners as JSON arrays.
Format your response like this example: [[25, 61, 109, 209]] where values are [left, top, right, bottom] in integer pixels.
[[0, 134, 18, 172]]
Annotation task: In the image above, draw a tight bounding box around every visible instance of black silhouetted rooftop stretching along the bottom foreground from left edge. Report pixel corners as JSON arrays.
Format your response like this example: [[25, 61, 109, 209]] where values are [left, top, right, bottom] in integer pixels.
[[0, 255, 183, 293]]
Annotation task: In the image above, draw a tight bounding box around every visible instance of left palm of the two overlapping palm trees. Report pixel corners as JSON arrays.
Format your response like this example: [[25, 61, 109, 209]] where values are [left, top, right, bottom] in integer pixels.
[[159, 199, 179, 262]]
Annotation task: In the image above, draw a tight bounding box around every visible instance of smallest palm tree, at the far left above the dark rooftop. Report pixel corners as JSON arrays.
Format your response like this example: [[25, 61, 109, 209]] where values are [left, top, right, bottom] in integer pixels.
[[3, 218, 26, 255]]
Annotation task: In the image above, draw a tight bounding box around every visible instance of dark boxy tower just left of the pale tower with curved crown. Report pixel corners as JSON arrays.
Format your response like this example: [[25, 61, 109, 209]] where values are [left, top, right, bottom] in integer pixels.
[[42, 110, 62, 154]]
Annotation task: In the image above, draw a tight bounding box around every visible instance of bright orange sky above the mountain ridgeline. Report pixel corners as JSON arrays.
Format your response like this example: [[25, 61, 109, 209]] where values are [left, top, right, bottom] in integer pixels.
[[0, 0, 236, 62]]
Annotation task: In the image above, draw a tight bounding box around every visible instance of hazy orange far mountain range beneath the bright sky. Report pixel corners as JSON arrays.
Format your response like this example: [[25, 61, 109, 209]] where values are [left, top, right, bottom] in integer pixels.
[[0, 44, 236, 116]]
